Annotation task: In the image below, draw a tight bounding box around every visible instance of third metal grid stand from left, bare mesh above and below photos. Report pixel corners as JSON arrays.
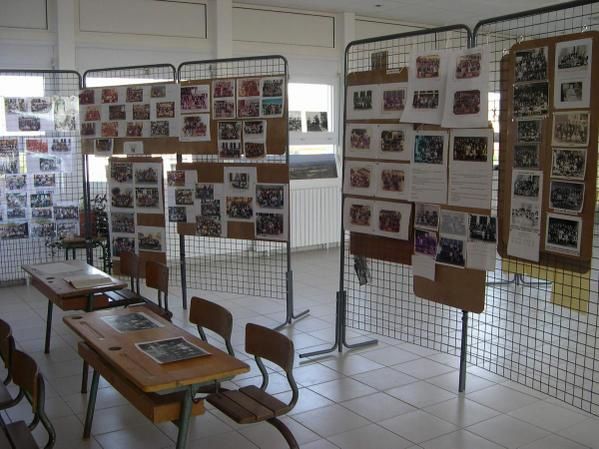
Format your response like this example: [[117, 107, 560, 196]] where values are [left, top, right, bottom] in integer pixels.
[[179, 56, 290, 299]]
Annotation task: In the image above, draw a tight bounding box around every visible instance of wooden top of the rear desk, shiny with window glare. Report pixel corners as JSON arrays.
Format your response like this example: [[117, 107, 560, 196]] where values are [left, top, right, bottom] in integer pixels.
[[21, 260, 127, 301]]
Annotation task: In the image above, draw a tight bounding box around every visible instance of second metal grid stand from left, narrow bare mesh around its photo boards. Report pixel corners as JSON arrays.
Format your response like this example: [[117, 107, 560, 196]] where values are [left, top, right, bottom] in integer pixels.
[[83, 64, 181, 278]]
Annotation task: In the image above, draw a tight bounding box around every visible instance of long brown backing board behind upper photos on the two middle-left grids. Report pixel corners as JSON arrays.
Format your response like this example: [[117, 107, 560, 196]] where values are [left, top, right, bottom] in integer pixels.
[[81, 74, 289, 155]]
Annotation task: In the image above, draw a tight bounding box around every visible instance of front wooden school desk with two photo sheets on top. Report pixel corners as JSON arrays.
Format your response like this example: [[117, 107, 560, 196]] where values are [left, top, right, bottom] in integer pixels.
[[63, 306, 250, 449]]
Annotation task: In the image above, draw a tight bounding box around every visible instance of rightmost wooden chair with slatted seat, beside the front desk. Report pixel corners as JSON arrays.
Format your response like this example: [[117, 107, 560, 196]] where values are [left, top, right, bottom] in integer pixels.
[[206, 323, 299, 449]]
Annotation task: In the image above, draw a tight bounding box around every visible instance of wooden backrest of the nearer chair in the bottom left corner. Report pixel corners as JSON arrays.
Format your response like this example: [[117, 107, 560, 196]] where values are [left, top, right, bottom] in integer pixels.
[[11, 349, 56, 449]]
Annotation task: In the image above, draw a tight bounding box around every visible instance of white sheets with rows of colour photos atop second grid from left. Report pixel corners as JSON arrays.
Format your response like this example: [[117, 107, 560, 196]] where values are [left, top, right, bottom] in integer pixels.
[[79, 83, 179, 140]]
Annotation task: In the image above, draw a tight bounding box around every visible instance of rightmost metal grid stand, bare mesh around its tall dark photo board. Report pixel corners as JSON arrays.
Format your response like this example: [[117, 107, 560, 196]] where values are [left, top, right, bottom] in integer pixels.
[[468, 1, 599, 414]]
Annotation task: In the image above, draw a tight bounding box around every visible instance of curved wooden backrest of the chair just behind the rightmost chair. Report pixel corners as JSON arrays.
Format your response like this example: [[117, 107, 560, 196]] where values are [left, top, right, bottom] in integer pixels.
[[189, 296, 235, 356]]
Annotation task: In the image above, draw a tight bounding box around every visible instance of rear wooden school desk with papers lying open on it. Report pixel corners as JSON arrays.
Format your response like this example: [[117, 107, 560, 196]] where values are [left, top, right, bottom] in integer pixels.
[[22, 260, 127, 354]]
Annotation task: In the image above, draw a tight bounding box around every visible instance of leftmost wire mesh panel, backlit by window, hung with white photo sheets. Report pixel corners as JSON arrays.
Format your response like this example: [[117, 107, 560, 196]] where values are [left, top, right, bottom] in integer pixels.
[[0, 70, 83, 285]]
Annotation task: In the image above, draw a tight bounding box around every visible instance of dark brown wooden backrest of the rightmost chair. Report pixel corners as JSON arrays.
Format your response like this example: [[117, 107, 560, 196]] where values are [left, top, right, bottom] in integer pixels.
[[245, 323, 295, 373]]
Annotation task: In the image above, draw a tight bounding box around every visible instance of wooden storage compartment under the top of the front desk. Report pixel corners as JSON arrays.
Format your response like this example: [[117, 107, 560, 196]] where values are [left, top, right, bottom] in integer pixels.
[[77, 342, 204, 424]]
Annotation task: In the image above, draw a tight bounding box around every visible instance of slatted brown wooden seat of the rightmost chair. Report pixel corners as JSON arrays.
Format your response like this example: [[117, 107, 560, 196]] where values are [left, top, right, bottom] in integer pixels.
[[206, 385, 290, 424]]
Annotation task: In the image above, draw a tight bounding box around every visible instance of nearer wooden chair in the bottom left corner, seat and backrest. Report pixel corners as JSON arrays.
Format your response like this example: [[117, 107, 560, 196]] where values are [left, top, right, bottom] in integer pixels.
[[4, 350, 56, 449]]
